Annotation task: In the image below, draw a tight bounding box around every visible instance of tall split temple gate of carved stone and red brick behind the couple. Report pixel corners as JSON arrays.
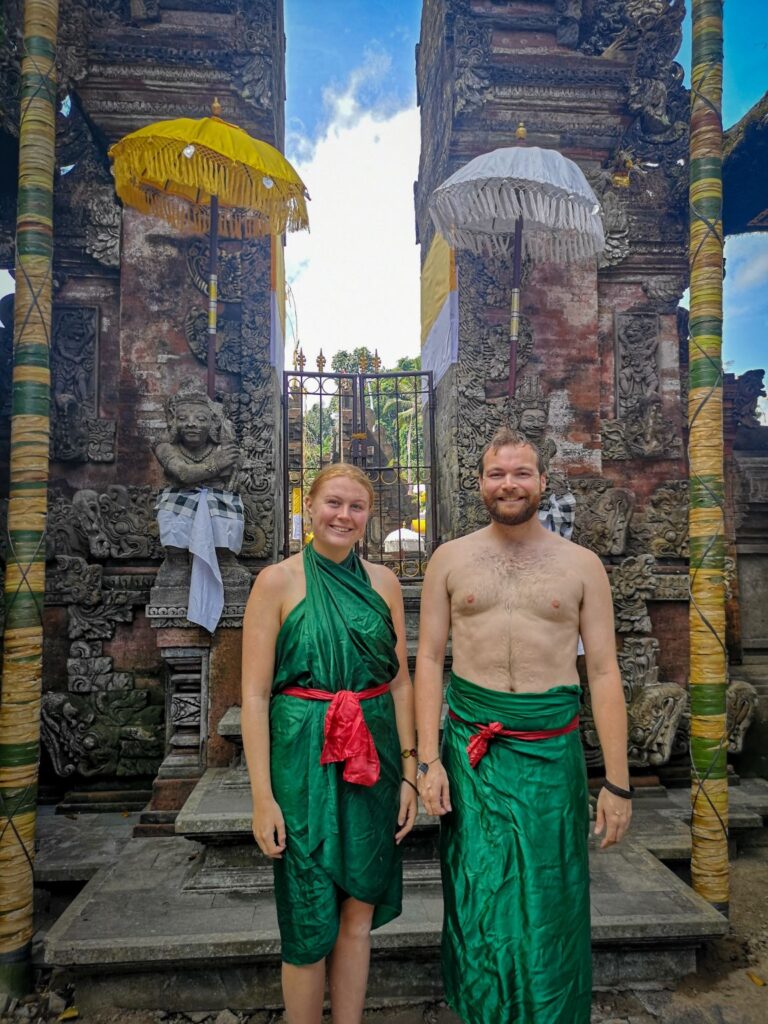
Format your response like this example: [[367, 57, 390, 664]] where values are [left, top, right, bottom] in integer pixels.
[[0, 0, 768, 1009]]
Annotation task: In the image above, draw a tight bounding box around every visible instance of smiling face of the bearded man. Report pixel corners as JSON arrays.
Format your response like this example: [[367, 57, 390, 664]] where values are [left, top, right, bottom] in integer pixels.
[[480, 444, 546, 526]]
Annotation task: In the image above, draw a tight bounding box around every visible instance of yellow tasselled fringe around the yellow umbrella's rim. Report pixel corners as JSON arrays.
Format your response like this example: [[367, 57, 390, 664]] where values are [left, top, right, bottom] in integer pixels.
[[115, 141, 308, 238]]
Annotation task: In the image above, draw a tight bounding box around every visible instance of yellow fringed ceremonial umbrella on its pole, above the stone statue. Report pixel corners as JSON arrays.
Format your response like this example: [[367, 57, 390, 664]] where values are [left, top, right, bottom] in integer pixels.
[[110, 99, 309, 397]]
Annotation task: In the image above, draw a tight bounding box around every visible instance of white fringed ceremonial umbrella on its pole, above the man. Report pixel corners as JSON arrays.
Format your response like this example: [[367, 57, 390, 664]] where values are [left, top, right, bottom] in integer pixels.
[[429, 126, 605, 398]]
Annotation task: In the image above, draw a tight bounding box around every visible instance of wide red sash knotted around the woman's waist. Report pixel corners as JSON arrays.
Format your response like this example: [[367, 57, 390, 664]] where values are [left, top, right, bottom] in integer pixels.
[[278, 683, 389, 785]]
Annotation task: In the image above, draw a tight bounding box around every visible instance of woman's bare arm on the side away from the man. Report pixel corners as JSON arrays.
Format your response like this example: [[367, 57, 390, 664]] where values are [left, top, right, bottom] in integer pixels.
[[241, 565, 286, 858]]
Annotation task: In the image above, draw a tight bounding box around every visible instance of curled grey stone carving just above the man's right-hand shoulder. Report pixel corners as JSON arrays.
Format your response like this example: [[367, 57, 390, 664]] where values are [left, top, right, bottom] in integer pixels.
[[570, 477, 635, 557]]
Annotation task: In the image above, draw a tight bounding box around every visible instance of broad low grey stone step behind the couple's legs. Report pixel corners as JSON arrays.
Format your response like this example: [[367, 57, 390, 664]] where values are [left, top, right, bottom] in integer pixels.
[[45, 838, 728, 1013]]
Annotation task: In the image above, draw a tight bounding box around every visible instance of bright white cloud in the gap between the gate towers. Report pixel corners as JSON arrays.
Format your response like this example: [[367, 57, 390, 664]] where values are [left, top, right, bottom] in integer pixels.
[[286, 53, 420, 369]]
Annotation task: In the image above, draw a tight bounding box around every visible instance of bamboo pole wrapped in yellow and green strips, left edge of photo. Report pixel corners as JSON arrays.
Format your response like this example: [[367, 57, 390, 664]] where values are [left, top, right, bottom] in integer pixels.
[[0, 0, 58, 995]]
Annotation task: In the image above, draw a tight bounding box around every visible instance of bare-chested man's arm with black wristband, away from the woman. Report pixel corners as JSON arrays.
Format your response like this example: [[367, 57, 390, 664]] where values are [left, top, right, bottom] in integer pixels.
[[580, 552, 632, 847]]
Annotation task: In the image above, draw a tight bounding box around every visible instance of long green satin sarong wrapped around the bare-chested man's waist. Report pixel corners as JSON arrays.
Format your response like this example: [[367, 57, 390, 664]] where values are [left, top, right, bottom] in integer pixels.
[[440, 674, 592, 1024]]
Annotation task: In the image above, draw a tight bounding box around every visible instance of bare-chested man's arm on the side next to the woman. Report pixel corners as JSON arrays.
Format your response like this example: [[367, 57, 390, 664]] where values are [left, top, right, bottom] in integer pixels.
[[415, 548, 451, 814]]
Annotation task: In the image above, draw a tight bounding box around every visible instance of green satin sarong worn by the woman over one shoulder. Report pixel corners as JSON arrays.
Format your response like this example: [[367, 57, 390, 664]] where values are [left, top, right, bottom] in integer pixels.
[[269, 545, 402, 964]]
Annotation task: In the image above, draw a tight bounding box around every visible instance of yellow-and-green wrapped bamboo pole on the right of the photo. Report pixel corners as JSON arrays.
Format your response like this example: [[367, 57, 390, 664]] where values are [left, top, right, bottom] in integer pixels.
[[688, 0, 729, 911]]
